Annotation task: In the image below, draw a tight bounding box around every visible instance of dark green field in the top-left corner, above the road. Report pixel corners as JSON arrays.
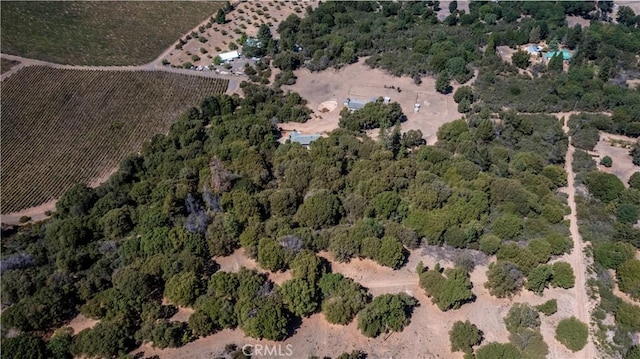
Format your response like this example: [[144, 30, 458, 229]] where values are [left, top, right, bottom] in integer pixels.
[[0, 1, 224, 65]]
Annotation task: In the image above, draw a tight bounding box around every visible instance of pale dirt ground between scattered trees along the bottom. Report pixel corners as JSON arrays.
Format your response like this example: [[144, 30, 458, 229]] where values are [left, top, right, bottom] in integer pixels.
[[139, 247, 593, 359]]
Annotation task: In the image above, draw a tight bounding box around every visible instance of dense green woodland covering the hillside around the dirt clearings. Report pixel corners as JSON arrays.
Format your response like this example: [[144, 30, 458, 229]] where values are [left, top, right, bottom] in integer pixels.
[[1, 1, 640, 358]]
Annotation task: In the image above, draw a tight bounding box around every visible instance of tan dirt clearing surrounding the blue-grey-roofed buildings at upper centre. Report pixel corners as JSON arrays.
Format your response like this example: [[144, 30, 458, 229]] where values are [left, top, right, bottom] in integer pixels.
[[279, 58, 462, 144]]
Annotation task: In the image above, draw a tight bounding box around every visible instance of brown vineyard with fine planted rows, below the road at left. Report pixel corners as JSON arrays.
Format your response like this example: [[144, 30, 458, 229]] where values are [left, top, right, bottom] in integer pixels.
[[0, 67, 228, 214]]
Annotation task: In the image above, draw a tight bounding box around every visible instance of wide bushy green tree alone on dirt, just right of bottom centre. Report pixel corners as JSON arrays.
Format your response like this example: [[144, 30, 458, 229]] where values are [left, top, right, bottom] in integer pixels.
[[358, 293, 418, 338]]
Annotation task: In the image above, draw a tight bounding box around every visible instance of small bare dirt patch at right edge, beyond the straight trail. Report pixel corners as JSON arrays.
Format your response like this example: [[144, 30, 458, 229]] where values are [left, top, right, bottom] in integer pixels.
[[594, 132, 640, 187]]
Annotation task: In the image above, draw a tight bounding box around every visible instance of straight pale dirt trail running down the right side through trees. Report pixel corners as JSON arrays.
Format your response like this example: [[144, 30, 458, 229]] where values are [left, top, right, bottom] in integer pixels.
[[556, 114, 597, 358]]
